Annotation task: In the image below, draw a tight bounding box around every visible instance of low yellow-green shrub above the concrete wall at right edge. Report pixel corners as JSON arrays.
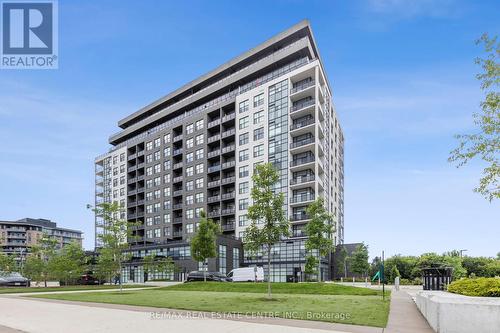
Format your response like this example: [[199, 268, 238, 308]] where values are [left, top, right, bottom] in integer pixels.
[[448, 278, 500, 297]]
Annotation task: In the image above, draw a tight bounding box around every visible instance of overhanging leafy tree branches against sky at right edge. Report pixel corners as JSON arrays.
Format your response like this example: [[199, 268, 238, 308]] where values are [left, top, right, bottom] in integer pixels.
[[448, 34, 500, 201]]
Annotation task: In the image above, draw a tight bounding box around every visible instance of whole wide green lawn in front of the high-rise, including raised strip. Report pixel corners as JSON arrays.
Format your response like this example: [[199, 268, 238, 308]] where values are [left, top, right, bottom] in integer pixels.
[[31, 283, 389, 327]]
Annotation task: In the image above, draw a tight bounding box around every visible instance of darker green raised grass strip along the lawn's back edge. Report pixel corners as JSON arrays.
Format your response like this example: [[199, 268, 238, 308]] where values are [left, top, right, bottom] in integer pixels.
[[161, 282, 387, 296]]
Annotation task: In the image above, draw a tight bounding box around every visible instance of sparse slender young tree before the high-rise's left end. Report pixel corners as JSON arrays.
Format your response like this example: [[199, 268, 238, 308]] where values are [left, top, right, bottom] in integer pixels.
[[93, 202, 137, 292]]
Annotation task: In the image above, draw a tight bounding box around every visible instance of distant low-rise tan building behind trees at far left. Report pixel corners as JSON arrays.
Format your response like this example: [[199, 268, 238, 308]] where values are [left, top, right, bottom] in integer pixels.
[[0, 218, 82, 260]]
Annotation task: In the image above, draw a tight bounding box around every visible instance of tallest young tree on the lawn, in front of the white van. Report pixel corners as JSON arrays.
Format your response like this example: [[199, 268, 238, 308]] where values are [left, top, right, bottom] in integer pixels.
[[245, 163, 290, 299]]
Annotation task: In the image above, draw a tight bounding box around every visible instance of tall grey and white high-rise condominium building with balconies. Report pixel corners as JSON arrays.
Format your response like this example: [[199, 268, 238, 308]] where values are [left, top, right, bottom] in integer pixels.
[[96, 21, 344, 281]]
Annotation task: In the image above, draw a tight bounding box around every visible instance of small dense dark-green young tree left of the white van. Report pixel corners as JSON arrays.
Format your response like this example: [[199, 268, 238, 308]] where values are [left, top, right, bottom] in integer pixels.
[[190, 211, 220, 282]]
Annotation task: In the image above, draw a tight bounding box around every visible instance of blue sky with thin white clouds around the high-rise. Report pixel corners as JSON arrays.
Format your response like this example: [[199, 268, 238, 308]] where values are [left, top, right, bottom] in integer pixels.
[[0, 0, 500, 256]]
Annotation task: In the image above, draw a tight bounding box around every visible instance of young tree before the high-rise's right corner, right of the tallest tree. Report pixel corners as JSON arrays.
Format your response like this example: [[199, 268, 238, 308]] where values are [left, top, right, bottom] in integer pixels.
[[305, 198, 335, 282]]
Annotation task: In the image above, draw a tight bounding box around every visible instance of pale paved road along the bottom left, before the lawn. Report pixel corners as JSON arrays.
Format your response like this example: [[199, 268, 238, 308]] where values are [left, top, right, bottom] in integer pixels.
[[0, 297, 364, 333]]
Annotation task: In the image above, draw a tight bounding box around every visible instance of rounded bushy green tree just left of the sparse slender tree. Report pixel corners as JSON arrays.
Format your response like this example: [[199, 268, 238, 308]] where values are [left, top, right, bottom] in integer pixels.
[[48, 242, 86, 285]]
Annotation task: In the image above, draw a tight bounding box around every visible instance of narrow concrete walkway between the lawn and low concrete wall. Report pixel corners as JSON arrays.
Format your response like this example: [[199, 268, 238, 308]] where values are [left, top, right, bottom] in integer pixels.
[[384, 290, 434, 333]]
